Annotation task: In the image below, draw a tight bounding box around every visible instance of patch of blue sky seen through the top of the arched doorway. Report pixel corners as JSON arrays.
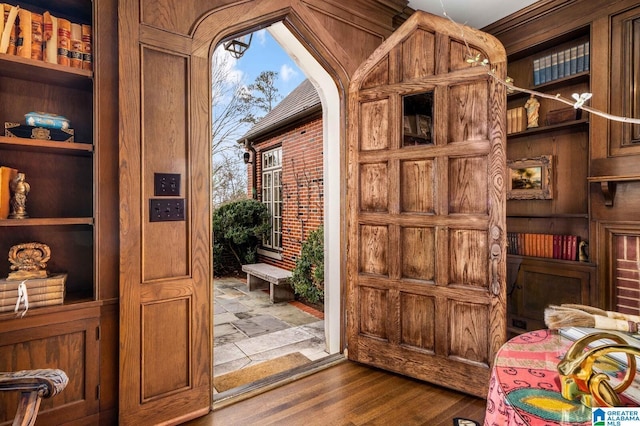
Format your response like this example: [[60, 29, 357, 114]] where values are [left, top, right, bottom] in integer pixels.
[[235, 30, 306, 98]]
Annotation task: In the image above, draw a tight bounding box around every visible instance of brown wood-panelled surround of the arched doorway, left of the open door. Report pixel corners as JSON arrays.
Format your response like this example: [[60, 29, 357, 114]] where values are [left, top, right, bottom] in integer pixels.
[[118, 0, 400, 424]]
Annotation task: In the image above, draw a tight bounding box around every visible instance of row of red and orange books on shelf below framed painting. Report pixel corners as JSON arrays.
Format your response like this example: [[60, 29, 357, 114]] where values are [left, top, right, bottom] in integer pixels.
[[507, 232, 580, 260]]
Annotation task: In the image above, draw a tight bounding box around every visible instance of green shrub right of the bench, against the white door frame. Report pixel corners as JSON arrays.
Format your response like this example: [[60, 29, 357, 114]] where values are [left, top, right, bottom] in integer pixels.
[[291, 226, 324, 303]]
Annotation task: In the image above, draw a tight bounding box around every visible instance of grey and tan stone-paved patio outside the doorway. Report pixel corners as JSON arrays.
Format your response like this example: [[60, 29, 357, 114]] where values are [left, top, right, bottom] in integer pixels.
[[213, 278, 328, 392]]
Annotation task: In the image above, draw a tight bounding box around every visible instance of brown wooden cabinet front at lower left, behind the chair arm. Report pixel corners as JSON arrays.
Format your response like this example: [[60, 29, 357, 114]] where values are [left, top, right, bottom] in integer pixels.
[[0, 304, 100, 426]]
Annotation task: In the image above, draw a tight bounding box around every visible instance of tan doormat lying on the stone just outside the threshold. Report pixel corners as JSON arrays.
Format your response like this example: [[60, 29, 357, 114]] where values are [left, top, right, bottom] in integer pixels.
[[213, 352, 311, 392]]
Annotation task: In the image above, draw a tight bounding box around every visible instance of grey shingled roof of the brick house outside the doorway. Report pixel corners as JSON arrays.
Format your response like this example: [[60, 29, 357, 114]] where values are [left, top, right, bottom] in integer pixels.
[[238, 79, 322, 143]]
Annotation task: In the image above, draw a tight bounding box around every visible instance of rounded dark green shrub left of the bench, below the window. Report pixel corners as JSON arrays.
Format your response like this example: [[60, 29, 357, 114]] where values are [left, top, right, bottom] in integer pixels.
[[213, 199, 271, 276]]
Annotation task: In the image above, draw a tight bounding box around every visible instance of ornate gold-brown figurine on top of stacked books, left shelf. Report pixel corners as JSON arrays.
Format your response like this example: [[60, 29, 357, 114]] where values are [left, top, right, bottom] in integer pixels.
[[7, 243, 51, 280]]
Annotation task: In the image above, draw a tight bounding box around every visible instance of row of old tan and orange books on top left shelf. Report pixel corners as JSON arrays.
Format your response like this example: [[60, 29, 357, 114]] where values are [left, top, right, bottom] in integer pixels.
[[0, 3, 93, 70]]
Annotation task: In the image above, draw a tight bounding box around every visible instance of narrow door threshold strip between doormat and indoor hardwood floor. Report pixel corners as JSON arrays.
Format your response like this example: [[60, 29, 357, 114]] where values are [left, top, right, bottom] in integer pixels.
[[212, 354, 347, 411]]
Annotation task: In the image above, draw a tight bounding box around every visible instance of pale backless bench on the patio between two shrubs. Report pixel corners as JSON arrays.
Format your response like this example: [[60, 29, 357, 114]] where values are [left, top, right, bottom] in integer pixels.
[[242, 263, 294, 303]]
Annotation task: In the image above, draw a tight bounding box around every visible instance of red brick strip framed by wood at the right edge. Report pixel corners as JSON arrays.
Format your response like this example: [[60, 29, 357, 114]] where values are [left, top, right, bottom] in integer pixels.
[[613, 235, 640, 315]]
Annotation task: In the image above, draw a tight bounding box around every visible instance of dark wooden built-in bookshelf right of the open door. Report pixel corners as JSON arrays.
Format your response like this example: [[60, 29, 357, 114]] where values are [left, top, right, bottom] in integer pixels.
[[507, 28, 596, 335]]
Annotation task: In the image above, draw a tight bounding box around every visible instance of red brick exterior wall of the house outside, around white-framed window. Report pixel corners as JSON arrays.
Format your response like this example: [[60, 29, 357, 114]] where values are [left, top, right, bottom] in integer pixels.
[[247, 117, 324, 270]]
